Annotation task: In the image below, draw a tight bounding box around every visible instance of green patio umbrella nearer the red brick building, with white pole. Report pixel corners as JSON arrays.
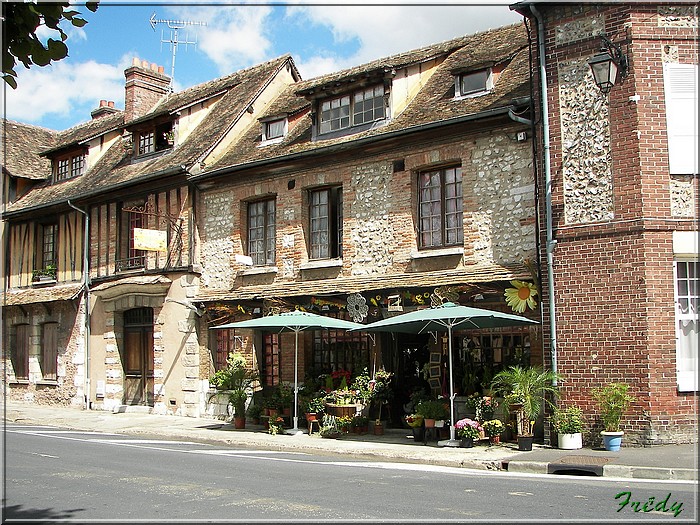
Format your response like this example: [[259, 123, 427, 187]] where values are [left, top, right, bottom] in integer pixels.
[[352, 303, 538, 447]]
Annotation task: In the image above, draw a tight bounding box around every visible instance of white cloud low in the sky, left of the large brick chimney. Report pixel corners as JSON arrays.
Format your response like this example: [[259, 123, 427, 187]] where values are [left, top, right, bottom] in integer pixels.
[[5, 61, 124, 128]]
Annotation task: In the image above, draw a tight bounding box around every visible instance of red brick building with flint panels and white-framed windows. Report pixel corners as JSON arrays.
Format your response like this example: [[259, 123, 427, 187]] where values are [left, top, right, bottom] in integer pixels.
[[513, 2, 700, 445]]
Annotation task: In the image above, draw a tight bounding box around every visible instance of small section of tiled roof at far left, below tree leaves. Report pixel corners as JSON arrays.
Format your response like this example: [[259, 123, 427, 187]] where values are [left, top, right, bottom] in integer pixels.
[[0, 119, 58, 180]]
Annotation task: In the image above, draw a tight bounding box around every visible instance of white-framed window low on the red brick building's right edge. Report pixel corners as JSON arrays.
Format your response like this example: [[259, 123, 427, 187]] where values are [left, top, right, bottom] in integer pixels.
[[675, 259, 700, 392]]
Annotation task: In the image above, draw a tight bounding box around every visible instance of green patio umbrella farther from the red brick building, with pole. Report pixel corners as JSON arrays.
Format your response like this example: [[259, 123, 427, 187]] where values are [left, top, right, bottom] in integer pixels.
[[212, 310, 364, 434]]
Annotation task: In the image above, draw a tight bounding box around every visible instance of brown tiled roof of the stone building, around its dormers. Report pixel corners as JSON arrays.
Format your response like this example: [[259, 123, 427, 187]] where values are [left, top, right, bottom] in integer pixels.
[[205, 24, 530, 172]]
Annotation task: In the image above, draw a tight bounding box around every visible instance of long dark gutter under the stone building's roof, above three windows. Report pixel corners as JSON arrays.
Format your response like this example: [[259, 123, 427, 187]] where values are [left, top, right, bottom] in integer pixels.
[[188, 101, 530, 183]]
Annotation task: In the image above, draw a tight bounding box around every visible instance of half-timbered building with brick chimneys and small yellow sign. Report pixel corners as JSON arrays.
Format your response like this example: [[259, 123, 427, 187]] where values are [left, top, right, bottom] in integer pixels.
[[3, 56, 299, 416]]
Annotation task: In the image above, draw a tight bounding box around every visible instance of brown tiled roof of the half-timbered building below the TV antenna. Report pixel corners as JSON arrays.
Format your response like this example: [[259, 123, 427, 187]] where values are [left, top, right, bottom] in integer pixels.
[[6, 55, 294, 214]]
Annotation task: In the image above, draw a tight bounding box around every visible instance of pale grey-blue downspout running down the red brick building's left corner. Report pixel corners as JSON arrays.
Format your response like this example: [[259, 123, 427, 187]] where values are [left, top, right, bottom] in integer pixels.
[[530, 4, 557, 386]]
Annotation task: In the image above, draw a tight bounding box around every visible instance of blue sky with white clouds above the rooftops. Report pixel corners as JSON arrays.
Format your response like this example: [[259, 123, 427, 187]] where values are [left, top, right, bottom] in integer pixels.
[[2, 0, 522, 130]]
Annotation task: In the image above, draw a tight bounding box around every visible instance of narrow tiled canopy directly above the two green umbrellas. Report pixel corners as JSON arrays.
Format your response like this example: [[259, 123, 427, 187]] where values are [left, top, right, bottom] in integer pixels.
[[194, 264, 532, 302]]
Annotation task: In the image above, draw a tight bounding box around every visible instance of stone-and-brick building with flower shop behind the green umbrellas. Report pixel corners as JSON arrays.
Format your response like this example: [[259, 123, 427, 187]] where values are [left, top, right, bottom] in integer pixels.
[[189, 24, 542, 425]]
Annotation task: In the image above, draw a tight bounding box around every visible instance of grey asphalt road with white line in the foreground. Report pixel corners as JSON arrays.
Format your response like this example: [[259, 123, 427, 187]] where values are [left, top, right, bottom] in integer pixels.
[[3, 424, 697, 523]]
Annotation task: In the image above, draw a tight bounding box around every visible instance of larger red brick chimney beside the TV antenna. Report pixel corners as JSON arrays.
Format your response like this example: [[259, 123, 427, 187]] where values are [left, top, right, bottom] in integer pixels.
[[124, 58, 170, 122]]
